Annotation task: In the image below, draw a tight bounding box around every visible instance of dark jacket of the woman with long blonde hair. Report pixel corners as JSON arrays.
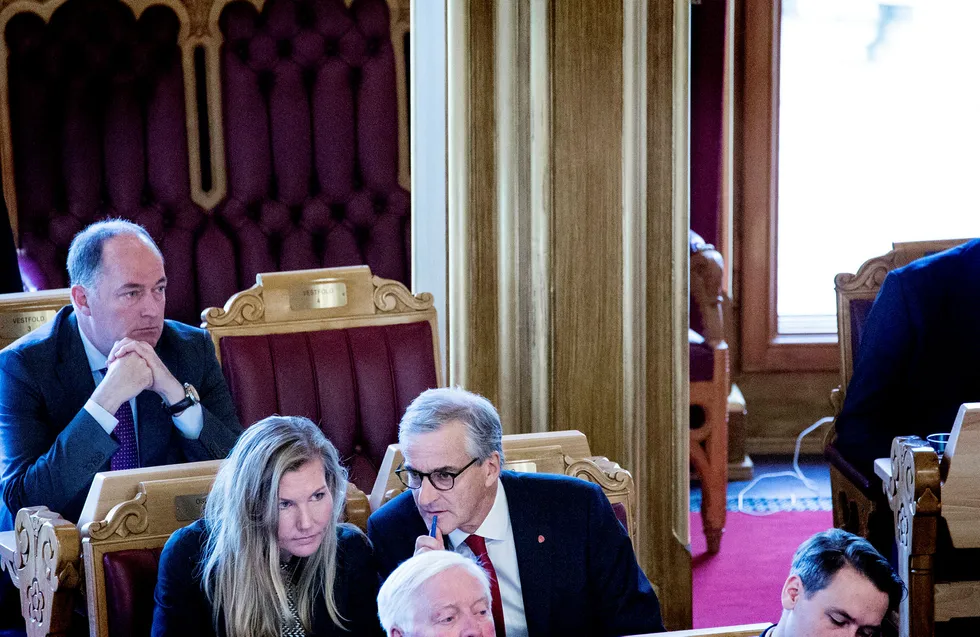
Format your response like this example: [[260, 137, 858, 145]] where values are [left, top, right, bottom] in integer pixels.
[[151, 520, 383, 637]]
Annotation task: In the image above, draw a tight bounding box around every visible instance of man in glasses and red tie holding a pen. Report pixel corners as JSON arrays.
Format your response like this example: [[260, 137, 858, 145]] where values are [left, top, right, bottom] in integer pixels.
[[368, 388, 664, 637]]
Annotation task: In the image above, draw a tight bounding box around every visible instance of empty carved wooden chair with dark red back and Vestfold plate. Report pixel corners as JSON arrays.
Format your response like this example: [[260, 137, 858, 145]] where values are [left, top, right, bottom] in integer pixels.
[[202, 266, 441, 492]]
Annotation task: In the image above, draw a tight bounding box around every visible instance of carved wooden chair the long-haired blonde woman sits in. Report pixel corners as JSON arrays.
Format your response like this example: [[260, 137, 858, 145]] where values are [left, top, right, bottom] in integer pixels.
[[2, 460, 368, 637]]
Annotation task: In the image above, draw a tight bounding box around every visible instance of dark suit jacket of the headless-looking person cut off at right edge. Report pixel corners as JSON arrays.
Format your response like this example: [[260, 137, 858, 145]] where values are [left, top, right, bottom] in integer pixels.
[[836, 240, 980, 476]]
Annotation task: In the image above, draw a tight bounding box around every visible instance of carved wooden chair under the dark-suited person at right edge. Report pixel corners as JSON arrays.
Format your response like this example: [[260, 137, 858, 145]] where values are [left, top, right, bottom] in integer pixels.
[[824, 239, 966, 555]]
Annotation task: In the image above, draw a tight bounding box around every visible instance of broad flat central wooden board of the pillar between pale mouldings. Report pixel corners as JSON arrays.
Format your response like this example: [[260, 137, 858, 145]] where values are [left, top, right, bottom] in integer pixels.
[[552, 1, 626, 458]]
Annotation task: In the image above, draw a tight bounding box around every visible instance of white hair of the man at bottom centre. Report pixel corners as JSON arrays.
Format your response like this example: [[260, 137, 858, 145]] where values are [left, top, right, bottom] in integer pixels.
[[378, 551, 490, 635]]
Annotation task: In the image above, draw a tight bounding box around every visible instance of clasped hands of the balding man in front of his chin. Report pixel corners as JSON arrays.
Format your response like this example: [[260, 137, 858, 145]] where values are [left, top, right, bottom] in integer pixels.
[[92, 337, 184, 414]]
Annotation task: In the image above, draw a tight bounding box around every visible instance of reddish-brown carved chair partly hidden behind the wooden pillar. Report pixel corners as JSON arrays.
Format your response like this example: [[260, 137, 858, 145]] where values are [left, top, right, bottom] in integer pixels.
[[688, 232, 728, 553]]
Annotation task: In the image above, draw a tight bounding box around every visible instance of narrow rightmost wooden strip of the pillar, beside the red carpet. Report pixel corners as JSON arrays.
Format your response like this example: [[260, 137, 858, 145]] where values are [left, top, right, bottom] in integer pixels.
[[652, 0, 691, 630]]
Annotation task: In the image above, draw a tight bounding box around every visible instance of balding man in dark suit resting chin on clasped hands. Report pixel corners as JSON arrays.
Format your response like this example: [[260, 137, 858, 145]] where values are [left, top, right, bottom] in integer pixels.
[[0, 220, 241, 530]]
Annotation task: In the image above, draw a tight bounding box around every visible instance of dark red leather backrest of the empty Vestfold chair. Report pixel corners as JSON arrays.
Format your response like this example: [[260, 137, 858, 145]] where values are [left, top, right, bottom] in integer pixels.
[[221, 323, 436, 492]]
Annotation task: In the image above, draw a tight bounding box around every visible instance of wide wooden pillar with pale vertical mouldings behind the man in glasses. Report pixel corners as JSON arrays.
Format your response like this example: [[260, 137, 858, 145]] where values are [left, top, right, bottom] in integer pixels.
[[447, 0, 691, 629]]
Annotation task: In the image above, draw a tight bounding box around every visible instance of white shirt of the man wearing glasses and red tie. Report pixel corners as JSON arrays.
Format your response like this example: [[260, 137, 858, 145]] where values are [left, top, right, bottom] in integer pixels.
[[449, 478, 527, 637]]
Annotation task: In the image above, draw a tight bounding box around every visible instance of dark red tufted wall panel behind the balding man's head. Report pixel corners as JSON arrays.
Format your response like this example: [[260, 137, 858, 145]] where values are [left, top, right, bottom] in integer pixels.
[[4, 0, 214, 322]]
